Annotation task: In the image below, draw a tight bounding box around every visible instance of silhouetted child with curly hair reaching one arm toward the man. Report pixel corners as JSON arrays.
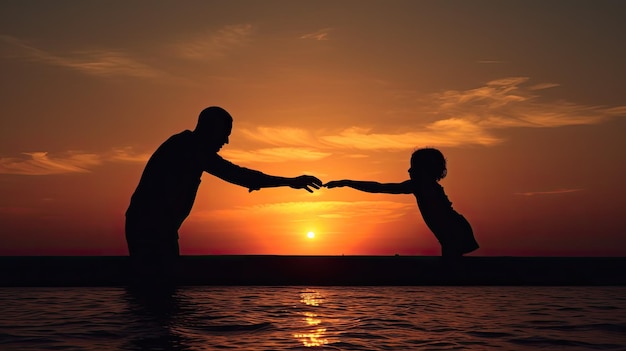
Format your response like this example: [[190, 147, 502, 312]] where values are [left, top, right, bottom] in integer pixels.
[[324, 148, 478, 258]]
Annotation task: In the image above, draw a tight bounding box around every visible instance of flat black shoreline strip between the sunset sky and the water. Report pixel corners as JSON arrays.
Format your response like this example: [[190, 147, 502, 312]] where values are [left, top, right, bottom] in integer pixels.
[[0, 255, 626, 287]]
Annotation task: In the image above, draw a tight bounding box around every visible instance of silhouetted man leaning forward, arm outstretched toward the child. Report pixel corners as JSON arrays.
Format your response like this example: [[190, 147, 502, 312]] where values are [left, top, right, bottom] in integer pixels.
[[125, 106, 322, 262]]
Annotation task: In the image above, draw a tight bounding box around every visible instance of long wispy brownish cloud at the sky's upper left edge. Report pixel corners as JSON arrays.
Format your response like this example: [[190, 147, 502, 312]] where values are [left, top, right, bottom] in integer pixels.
[[0, 35, 163, 78]]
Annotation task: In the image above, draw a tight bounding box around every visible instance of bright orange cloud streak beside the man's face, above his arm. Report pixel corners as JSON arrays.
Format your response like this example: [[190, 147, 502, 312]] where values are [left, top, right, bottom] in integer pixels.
[[220, 147, 331, 163]]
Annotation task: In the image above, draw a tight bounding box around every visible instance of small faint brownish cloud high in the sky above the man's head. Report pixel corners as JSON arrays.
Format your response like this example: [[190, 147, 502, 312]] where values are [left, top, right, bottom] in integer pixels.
[[175, 24, 254, 60]]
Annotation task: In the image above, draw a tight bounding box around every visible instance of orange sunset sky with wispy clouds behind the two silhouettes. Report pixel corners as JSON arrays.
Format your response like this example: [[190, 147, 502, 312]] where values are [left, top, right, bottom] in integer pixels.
[[0, 0, 626, 256]]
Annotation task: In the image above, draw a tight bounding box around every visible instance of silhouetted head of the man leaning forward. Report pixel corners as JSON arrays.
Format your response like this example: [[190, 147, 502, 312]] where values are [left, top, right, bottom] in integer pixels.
[[194, 106, 233, 152]]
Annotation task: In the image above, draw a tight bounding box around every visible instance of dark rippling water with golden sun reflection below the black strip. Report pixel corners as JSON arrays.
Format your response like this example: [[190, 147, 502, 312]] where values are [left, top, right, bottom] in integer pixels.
[[0, 286, 626, 351]]
